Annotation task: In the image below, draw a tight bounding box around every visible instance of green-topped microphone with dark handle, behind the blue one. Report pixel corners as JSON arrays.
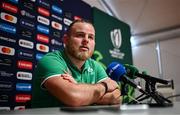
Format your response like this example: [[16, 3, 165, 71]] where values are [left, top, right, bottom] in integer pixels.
[[124, 64, 169, 84]]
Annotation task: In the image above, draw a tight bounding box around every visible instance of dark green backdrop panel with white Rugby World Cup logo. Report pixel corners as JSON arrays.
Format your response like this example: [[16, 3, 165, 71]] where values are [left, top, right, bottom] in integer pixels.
[[93, 8, 134, 103]]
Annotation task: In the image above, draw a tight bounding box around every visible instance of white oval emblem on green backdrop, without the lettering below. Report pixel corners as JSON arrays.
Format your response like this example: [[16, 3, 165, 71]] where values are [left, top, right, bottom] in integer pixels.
[[111, 29, 122, 49]]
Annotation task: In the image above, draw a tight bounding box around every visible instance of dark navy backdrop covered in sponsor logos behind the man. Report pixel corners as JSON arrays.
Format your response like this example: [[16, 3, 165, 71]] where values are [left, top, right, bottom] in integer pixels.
[[0, 0, 92, 110]]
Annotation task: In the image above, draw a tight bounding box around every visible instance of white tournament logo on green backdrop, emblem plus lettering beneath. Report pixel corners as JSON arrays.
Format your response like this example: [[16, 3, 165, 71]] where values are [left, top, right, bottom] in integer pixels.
[[109, 29, 125, 59]]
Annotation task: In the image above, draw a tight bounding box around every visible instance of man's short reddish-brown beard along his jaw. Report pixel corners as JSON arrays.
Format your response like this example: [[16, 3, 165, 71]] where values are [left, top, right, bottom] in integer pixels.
[[66, 43, 93, 61]]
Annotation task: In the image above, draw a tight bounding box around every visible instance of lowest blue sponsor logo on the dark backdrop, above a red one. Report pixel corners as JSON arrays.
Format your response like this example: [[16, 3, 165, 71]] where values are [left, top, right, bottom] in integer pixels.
[[16, 83, 31, 91]]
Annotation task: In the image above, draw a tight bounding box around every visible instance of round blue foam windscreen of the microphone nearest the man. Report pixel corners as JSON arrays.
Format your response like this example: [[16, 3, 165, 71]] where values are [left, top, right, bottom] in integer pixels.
[[106, 62, 126, 81]]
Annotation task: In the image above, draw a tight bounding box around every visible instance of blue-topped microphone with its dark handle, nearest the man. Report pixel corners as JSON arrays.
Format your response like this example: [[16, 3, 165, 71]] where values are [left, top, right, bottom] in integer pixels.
[[106, 62, 148, 94]]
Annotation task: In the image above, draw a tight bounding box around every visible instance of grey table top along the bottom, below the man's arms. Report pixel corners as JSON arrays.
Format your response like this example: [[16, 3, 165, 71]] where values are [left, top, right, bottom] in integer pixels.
[[0, 102, 180, 115]]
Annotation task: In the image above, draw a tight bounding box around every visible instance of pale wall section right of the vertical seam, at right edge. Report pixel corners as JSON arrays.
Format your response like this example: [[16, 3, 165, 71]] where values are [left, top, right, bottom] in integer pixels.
[[160, 37, 180, 101]]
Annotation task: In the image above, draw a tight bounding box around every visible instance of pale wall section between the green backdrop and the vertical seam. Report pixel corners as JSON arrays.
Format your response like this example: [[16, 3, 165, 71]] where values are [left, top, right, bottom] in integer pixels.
[[132, 43, 158, 76]]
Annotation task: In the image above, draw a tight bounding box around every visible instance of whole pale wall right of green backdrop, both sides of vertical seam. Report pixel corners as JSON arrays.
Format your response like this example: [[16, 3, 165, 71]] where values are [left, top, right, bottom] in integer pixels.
[[132, 38, 180, 101]]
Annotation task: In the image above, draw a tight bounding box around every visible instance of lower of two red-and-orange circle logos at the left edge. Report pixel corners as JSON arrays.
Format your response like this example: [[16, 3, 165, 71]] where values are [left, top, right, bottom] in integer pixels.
[[0, 45, 15, 56]]
